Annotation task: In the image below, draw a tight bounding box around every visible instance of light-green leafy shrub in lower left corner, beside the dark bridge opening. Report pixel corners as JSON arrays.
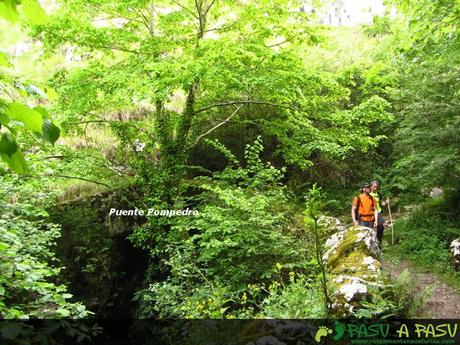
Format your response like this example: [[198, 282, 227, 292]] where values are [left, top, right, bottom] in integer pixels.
[[0, 177, 90, 319]]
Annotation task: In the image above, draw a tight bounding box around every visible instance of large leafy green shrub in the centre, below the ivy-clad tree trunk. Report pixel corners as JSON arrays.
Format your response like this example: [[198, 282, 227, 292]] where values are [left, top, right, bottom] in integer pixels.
[[137, 139, 316, 317]]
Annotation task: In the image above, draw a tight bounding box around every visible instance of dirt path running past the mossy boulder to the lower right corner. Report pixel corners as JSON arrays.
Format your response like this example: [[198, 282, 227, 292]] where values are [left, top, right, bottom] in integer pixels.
[[382, 254, 460, 319]]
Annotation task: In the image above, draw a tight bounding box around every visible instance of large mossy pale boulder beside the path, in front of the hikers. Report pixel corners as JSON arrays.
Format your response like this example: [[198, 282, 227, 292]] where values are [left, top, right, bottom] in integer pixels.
[[323, 226, 382, 317]]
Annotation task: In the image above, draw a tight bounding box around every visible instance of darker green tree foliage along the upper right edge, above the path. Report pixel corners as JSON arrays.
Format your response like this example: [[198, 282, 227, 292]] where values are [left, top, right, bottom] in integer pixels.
[[392, 1, 460, 199]]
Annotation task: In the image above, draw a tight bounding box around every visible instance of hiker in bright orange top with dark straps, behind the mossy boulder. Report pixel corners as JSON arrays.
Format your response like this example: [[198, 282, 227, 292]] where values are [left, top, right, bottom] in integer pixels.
[[351, 183, 379, 229]]
